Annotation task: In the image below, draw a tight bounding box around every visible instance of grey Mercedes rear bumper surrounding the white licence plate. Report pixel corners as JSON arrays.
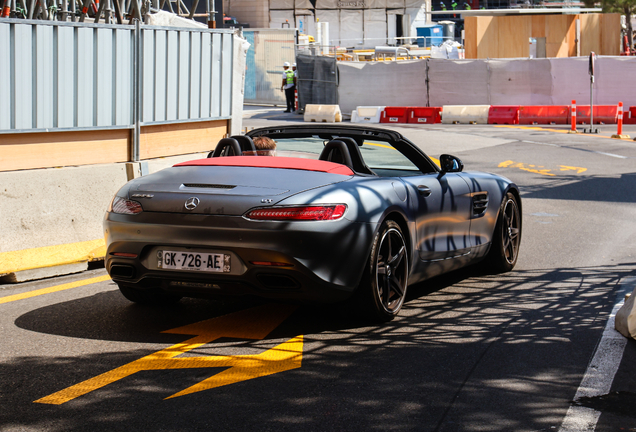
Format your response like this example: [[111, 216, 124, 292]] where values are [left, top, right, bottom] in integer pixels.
[[104, 212, 375, 303]]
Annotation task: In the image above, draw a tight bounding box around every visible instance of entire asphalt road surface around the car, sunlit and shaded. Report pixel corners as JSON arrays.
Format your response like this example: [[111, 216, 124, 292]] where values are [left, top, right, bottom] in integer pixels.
[[0, 112, 636, 431]]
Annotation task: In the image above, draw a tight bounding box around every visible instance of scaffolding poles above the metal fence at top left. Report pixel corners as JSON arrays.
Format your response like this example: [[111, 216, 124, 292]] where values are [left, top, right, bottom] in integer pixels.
[[0, 0, 217, 24]]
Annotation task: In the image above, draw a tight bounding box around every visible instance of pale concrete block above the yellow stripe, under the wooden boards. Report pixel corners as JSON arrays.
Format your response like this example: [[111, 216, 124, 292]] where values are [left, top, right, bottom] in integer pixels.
[[0, 163, 128, 253]]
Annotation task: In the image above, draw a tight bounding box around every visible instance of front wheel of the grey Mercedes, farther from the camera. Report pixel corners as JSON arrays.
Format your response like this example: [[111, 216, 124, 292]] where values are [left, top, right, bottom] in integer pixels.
[[486, 192, 521, 273]]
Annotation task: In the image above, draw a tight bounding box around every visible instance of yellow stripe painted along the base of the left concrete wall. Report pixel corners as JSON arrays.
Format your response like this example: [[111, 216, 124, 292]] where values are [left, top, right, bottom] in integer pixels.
[[0, 238, 106, 275]]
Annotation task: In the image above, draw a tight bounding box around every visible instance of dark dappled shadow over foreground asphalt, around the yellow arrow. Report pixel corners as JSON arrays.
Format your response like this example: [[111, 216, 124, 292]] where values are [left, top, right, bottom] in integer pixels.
[[0, 265, 635, 431]]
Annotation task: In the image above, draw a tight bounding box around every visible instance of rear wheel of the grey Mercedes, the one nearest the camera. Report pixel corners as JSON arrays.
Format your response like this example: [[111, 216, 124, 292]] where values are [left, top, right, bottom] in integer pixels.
[[356, 220, 409, 322]]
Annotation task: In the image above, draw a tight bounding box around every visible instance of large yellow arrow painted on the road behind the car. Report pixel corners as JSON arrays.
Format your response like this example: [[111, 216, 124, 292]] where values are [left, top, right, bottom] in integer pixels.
[[35, 304, 303, 405]]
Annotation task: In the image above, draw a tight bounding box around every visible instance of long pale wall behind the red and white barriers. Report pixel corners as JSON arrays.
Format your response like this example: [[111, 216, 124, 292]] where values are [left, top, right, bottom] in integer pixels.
[[332, 56, 636, 115]]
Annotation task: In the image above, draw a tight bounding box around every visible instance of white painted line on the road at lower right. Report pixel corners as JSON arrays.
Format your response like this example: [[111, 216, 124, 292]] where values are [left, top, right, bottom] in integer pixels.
[[559, 278, 636, 432]]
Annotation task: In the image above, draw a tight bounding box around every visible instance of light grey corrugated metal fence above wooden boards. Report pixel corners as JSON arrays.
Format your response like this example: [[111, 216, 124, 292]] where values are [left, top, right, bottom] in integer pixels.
[[0, 19, 234, 134]]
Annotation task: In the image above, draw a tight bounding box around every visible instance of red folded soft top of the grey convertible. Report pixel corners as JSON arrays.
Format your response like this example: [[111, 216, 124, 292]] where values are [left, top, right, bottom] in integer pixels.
[[174, 156, 353, 175]]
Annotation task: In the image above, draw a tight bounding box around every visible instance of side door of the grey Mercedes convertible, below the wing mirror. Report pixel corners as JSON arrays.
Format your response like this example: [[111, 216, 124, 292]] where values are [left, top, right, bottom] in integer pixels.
[[402, 173, 472, 264]]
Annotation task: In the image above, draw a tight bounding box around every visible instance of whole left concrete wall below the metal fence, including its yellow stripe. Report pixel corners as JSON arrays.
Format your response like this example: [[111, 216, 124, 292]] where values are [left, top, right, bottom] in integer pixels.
[[0, 153, 209, 282]]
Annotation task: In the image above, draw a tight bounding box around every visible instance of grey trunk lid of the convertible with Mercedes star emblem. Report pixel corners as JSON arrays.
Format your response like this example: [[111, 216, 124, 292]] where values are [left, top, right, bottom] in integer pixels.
[[128, 166, 352, 216]]
